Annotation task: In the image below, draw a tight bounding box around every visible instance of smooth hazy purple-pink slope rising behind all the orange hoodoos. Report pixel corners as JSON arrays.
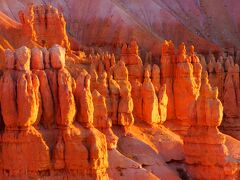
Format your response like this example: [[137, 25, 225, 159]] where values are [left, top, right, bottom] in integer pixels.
[[0, 0, 240, 53]]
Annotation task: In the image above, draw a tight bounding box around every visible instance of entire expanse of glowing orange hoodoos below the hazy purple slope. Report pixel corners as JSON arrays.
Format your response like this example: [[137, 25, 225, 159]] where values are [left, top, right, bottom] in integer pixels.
[[0, 2, 240, 180]]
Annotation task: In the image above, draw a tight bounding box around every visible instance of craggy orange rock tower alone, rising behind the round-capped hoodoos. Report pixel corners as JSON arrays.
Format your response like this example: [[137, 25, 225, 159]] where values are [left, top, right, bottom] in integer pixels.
[[19, 5, 70, 50]]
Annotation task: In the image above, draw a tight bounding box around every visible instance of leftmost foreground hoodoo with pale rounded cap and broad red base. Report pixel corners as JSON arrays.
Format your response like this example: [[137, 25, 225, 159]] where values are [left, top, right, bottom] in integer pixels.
[[0, 47, 50, 177]]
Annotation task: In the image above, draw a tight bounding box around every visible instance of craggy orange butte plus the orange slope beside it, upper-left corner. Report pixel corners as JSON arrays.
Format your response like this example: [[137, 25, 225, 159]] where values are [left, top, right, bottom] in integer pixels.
[[0, 2, 75, 63]]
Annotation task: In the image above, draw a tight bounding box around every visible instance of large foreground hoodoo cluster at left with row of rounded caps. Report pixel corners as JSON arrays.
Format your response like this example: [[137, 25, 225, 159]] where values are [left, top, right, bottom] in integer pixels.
[[0, 45, 108, 179]]
